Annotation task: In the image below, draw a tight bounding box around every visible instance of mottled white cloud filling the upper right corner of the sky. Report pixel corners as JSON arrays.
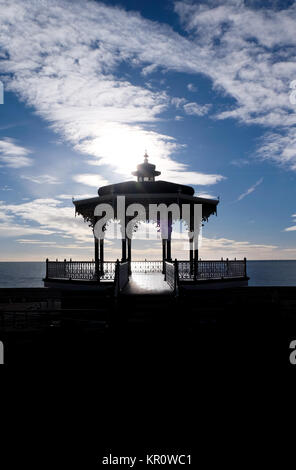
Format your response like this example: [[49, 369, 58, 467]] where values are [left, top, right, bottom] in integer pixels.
[[175, 0, 296, 171]]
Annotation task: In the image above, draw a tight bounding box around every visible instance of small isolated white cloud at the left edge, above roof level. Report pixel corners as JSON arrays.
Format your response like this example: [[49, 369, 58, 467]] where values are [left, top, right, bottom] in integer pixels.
[[0, 137, 33, 168]]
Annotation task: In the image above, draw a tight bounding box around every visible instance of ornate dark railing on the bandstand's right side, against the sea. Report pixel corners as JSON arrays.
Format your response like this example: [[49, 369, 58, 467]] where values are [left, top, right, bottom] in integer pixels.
[[178, 259, 247, 281]]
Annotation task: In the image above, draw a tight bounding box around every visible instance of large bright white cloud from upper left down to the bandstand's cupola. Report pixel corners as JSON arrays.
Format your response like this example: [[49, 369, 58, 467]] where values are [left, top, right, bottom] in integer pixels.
[[0, 0, 224, 184]]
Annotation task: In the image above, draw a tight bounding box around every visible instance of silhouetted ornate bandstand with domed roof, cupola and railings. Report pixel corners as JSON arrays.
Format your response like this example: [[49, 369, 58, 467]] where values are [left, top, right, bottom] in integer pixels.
[[44, 154, 248, 296]]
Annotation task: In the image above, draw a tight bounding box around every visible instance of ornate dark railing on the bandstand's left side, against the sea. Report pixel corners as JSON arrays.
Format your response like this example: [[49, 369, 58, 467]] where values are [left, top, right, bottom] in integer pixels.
[[46, 260, 115, 281]]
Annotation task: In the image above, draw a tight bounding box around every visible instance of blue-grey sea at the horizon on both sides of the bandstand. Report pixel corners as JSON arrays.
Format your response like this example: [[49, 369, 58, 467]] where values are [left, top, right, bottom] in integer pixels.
[[0, 260, 296, 288]]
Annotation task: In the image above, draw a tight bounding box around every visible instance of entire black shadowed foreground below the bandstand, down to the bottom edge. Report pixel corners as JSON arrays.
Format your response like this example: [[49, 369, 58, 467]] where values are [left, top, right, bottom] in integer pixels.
[[0, 287, 296, 469]]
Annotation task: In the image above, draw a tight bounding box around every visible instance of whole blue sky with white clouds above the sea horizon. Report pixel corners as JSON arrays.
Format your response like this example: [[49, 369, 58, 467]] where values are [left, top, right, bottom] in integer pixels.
[[0, 0, 296, 261]]
